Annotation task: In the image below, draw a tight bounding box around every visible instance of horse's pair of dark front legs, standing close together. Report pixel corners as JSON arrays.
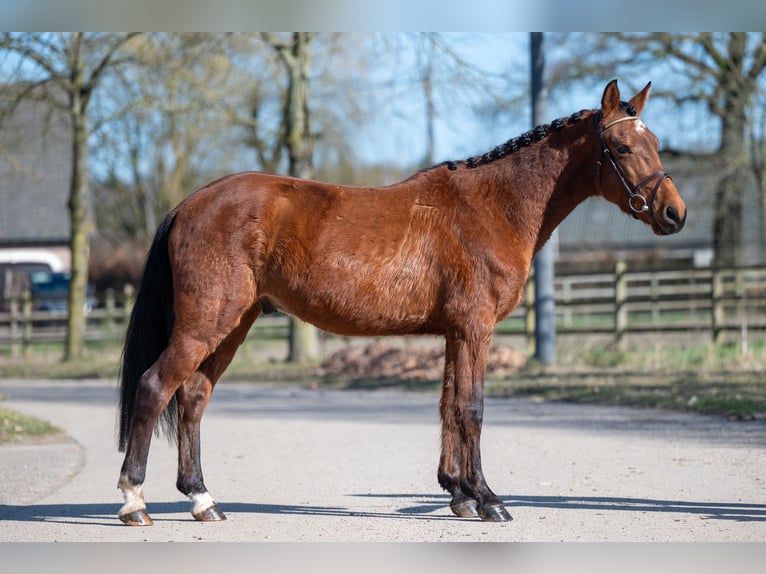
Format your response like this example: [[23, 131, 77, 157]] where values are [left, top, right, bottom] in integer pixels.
[[438, 331, 511, 522]]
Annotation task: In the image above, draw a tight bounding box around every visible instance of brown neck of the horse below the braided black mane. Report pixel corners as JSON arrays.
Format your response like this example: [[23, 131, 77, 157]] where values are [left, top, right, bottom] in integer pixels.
[[496, 114, 597, 253]]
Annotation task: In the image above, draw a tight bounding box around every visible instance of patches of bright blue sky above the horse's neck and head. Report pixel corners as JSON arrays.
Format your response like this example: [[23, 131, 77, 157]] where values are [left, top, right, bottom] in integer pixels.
[[355, 33, 718, 171]]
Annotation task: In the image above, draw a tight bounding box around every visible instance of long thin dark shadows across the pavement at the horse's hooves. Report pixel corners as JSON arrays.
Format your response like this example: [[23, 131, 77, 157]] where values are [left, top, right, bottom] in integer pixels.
[[0, 494, 766, 527]]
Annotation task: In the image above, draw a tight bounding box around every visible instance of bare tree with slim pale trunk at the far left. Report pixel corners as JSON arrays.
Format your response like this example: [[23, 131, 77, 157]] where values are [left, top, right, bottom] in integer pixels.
[[0, 32, 142, 360]]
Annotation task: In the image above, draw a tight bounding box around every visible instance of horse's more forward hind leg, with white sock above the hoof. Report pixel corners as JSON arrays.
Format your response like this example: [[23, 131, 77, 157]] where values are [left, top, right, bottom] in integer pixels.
[[176, 307, 259, 522]]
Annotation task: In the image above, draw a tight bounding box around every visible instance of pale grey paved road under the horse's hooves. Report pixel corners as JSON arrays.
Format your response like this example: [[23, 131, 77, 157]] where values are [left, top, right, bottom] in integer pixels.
[[0, 380, 766, 542]]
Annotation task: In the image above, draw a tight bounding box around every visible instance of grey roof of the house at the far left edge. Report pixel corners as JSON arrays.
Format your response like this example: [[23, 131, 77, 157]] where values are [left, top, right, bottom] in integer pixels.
[[0, 85, 71, 245]]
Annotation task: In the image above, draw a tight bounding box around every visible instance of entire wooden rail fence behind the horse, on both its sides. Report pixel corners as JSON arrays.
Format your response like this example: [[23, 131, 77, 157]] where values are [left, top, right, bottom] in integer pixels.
[[0, 262, 766, 355]]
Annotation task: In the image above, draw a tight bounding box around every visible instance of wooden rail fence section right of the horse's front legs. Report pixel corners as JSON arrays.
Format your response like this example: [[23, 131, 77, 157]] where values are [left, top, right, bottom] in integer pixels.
[[508, 261, 766, 352]]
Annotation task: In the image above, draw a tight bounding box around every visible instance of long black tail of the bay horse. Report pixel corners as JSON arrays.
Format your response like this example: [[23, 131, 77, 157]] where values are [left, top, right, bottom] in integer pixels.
[[119, 213, 178, 451]]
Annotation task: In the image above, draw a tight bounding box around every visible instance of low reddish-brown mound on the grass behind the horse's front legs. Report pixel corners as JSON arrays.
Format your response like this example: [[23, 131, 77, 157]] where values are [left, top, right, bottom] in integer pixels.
[[317, 341, 526, 381]]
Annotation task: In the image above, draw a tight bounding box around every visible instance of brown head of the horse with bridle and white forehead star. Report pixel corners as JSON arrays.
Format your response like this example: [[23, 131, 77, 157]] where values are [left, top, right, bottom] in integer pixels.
[[596, 80, 686, 235]]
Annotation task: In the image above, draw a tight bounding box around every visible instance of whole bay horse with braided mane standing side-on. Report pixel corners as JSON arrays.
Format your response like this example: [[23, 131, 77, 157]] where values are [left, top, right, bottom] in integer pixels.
[[118, 80, 686, 526]]
